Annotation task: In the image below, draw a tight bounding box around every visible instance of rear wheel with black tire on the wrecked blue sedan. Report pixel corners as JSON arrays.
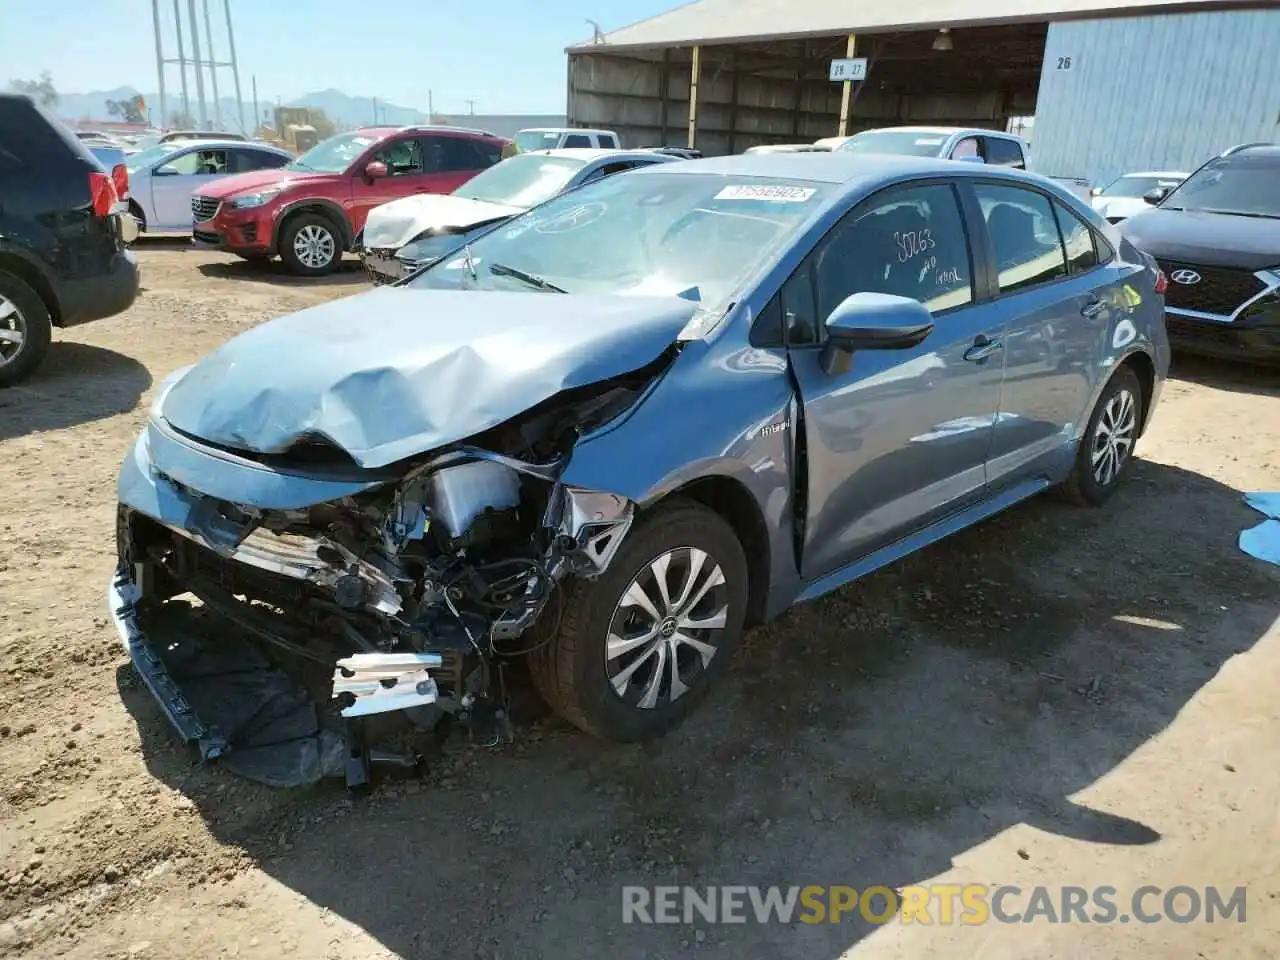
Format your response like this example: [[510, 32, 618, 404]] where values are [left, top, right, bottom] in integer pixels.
[[1061, 366, 1144, 507]]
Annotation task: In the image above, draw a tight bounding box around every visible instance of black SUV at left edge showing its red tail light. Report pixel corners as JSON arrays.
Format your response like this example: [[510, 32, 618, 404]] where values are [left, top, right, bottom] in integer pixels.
[[0, 93, 138, 387]]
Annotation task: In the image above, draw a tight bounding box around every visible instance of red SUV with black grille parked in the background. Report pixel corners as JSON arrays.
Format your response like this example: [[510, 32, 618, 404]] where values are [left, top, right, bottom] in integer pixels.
[[191, 127, 513, 276]]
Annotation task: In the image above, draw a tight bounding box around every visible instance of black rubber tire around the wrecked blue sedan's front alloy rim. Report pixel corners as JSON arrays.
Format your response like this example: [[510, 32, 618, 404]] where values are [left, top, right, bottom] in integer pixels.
[[529, 499, 748, 742]]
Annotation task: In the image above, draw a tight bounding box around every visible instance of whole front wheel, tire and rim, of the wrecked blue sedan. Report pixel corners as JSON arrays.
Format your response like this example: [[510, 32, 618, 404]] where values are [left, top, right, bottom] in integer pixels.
[[530, 500, 748, 741]]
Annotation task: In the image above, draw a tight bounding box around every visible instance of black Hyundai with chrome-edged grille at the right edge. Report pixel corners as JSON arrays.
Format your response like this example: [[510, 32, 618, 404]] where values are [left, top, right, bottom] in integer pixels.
[[1120, 143, 1280, 364]]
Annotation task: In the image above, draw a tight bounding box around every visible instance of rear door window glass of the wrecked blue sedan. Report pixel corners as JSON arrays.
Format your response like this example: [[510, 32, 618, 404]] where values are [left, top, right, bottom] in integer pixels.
[[974, 183, 1066, 293]]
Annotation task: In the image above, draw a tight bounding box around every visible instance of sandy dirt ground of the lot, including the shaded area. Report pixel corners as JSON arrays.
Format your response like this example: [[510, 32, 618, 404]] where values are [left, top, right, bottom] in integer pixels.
[[0, 243, 1280, 960]]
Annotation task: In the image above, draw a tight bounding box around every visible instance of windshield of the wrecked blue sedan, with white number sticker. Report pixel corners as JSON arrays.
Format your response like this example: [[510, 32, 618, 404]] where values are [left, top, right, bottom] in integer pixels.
[[411, 170, 833, 306]]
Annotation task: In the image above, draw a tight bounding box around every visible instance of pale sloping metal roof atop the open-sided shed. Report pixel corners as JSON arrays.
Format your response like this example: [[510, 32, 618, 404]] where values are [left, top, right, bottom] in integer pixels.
[[568, 0, 1275, 52]]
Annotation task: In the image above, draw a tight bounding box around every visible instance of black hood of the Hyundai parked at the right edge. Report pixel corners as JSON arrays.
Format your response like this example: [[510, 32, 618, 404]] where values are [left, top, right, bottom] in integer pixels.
[[1120, 207, 1280, 270]]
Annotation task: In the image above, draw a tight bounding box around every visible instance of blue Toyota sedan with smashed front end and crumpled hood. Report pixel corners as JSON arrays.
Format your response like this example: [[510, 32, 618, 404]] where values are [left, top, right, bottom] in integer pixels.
[[109, 155, 1167, 785]]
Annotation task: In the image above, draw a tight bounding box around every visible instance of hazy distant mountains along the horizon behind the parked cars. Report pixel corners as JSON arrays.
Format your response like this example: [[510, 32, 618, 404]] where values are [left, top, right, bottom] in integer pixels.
[[58, 81, 564, 137]]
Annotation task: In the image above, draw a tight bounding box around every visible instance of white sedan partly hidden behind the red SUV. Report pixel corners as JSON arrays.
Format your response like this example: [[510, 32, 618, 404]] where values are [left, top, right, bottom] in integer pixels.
[[124, 140, 293, 233]]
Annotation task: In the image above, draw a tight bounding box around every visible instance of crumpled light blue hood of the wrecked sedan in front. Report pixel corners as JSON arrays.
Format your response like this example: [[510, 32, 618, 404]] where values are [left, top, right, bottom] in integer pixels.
[[160, 287, 698, 468]]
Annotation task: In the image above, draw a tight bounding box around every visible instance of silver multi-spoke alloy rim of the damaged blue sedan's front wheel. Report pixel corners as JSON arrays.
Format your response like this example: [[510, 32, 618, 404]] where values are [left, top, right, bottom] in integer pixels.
[[604, 547, 728, 709]]
